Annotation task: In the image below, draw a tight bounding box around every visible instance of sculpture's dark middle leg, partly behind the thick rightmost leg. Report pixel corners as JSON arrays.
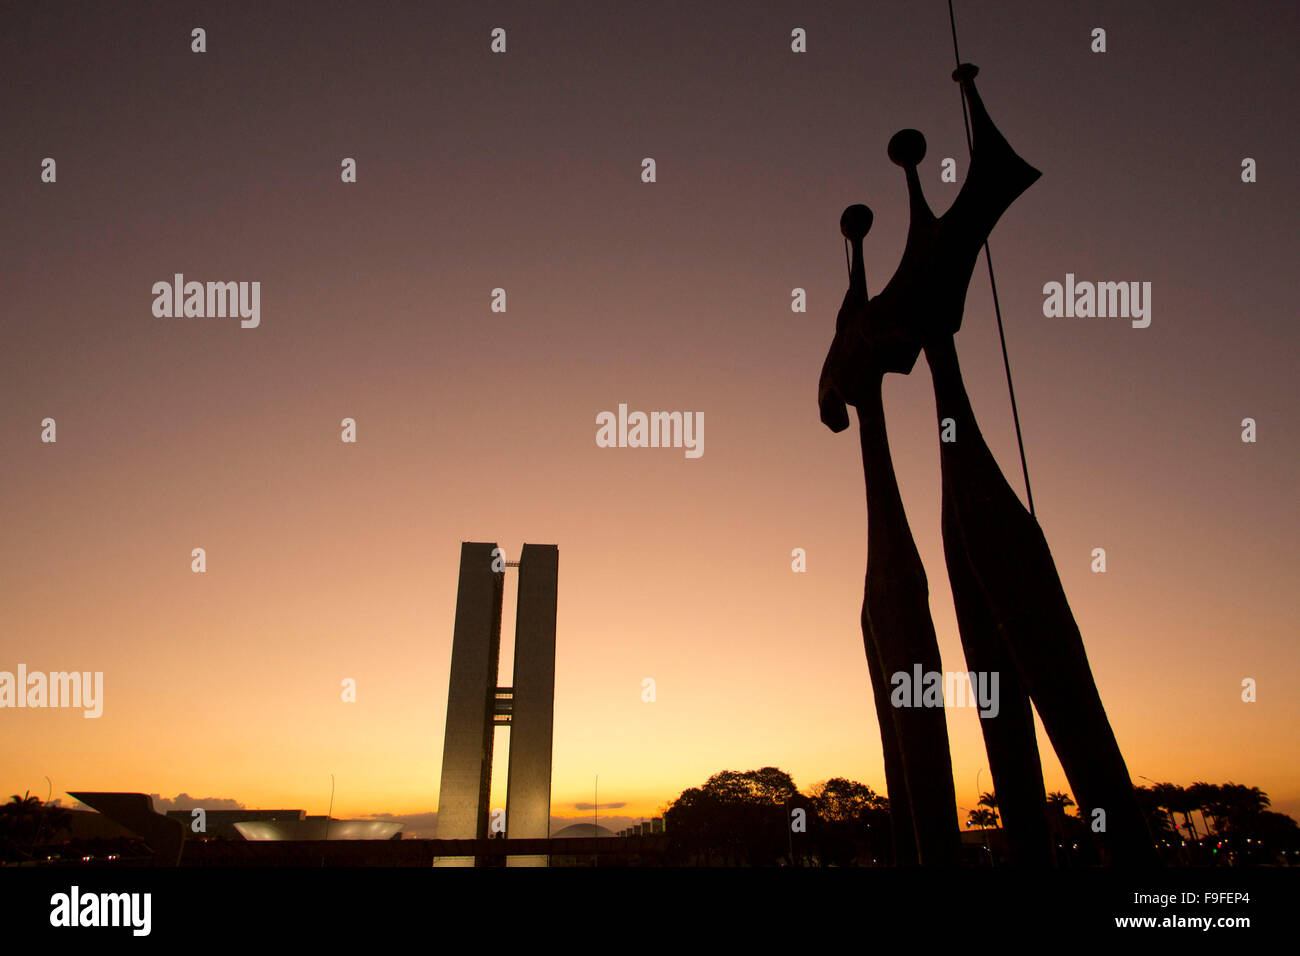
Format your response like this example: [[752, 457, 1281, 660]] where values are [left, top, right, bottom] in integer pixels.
[[943, 494, 1052, 868]]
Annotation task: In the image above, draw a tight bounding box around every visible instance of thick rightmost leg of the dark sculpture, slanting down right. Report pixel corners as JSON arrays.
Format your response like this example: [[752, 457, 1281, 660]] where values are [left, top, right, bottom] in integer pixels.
[[926, 338, 1156, 865]]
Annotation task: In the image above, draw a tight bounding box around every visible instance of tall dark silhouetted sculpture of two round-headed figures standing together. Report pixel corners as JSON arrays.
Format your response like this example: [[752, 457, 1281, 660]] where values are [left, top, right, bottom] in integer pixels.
[[818, 64, 1154, 865]]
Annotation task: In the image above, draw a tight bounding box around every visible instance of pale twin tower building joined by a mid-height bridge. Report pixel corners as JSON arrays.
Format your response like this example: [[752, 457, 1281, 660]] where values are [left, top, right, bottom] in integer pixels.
[[438, 541, 559, 866]]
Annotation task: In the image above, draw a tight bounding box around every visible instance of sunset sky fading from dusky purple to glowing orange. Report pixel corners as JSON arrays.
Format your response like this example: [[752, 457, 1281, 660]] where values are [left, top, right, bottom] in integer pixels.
[[0, 0, 1300, 837]]
